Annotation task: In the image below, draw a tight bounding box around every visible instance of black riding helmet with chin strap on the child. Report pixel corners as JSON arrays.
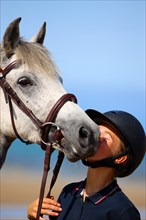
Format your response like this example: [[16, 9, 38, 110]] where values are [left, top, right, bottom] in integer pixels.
[[83, 109, 146, 177]]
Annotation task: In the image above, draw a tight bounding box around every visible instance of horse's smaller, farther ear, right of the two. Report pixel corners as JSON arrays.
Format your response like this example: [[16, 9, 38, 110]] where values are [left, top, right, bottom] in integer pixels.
[[29, 22, 46, 44]]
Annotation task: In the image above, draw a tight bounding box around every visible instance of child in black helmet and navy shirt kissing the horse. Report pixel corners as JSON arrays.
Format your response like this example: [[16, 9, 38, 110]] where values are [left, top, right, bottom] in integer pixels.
[[28, 110, 146, 220]]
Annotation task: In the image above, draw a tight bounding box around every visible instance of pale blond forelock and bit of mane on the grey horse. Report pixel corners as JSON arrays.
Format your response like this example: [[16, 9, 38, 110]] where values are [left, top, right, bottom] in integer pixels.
[[0, 40, 60, 79]]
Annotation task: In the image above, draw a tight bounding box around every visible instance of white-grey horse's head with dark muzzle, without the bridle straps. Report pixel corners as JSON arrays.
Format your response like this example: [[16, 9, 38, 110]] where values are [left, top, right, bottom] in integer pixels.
[[0, 18, 99, 166]]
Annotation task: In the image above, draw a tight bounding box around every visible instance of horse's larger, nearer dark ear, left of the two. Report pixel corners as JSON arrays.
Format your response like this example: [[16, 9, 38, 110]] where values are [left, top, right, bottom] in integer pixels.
[[3, 17, 21, 57]]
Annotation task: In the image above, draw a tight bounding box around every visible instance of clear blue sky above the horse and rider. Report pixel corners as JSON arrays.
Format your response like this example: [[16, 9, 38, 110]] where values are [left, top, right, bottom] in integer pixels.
[[0, 0, 146, 128]]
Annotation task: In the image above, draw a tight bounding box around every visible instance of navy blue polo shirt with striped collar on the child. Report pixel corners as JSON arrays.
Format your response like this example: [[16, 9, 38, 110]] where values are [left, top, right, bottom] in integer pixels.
[[50, 180, 140, 220]]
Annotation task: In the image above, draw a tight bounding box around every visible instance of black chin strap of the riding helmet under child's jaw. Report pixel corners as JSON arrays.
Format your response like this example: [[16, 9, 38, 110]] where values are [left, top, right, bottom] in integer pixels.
[[82, 148, 129, 170]]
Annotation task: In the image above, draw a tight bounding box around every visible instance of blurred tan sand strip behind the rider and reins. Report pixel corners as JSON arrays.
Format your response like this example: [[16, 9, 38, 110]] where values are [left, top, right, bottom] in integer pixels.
[[0, 168, 146, 208]]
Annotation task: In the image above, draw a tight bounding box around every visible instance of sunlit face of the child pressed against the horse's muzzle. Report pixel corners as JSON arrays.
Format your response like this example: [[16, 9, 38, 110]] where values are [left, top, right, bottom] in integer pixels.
[[87, 125, 121, 161]]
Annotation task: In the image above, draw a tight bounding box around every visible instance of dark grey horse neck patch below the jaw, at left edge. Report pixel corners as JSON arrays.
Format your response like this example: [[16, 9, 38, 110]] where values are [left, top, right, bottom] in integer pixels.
[[0, 131, 13, 169]]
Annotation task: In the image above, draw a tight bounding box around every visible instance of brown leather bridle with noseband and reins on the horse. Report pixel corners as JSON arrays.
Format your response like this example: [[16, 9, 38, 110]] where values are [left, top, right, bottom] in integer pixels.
[[0, 60, 77, 220]]
